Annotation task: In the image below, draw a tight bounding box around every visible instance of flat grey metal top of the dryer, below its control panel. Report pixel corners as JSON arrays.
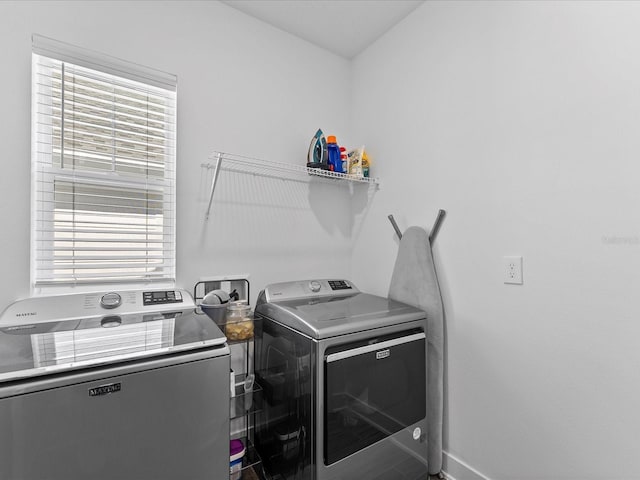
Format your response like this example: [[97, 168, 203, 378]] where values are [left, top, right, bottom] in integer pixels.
[[256, 293, 426, 339]]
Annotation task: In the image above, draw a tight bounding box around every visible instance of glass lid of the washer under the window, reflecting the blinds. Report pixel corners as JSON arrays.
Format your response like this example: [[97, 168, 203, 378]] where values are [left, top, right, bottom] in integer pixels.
[[0, 308, 228, 382]]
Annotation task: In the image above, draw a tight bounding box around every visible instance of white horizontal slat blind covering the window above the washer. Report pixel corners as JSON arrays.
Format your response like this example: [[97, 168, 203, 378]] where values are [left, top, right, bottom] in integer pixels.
[[31, 37, 176, 287]]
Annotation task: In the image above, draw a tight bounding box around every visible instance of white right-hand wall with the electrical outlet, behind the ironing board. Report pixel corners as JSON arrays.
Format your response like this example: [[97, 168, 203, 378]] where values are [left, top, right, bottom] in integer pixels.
[[352, 1, 640, 480]]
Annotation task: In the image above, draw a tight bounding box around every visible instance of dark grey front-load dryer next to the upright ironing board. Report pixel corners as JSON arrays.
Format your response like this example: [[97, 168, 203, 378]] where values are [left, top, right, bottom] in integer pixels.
[[255, 280, 428, 480]]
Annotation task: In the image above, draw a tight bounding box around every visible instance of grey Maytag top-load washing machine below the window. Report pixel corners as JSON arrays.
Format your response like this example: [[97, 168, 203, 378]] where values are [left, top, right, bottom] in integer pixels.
[[0, 290, 230, 480]]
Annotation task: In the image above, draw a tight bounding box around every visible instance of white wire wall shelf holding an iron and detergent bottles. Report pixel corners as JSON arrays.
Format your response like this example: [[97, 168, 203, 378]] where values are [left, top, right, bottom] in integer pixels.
[[201, 152, 380, 218]]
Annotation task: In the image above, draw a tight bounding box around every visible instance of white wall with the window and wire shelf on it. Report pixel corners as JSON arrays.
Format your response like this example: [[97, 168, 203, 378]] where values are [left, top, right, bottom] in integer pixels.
[[0, 1, 358, 310]]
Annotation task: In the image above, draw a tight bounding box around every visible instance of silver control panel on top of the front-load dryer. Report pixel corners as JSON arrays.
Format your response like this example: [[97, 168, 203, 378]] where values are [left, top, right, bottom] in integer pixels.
[[264, 279, 360, 302]]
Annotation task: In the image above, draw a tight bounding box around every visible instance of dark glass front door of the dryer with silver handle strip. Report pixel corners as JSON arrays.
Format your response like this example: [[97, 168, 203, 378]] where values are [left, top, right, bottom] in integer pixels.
[[324, 331, 427, 465]]
